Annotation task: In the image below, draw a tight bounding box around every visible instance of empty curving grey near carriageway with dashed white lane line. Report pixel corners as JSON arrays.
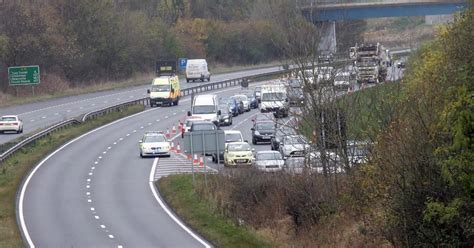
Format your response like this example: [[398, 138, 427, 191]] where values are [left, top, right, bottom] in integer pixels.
[[18, 81, 266, 247]]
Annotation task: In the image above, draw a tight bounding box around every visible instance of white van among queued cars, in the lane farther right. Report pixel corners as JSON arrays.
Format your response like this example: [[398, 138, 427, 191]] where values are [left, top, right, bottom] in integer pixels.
[[259, 84, 290, 117]]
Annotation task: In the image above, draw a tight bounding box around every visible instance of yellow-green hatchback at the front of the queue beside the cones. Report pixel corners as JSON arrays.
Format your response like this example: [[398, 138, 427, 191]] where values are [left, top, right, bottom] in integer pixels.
[[224, 142, 253, 167]]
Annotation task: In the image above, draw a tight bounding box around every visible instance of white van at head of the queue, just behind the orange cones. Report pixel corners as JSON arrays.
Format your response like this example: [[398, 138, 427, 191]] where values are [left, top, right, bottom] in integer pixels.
[[188, 95, 221, 125]]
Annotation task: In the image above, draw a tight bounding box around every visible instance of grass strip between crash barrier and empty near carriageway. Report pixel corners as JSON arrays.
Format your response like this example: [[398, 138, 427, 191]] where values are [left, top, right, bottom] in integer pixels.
[[0, 105, 143, 247]]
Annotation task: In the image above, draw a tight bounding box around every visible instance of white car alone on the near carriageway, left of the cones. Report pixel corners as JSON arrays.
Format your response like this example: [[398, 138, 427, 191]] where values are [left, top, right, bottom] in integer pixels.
[[139, 132, 171, 158]]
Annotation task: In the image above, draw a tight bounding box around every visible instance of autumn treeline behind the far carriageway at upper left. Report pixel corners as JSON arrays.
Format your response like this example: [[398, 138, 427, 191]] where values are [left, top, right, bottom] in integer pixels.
[[0, 0, 282, 90]]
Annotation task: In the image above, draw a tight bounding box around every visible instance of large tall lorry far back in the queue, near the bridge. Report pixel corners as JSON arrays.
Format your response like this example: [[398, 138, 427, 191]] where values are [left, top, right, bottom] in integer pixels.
[[349, 43, 392, 84]]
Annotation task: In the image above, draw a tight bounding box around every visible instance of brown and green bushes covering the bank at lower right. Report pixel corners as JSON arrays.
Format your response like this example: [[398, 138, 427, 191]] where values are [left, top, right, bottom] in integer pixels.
[[161, 4, 474, 247]]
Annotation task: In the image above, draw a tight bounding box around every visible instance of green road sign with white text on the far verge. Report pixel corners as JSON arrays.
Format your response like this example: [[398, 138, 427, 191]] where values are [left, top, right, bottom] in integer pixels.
[[8, 65, 40, 86]]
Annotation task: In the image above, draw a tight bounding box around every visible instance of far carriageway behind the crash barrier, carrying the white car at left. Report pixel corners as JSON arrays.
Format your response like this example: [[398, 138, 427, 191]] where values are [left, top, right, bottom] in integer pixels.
[[0, 67, 281, 144]]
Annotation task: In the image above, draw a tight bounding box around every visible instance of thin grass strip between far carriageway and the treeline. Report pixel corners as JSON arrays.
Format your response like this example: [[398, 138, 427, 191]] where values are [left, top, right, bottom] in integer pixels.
[[0, 61, 281, 107]]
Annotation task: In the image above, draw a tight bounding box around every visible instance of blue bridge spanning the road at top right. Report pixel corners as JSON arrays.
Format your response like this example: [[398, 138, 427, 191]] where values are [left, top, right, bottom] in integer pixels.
[[300, 0, 468, 22]]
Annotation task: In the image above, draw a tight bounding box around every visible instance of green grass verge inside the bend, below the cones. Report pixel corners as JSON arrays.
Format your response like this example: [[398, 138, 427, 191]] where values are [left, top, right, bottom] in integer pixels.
[[156, 175, 274, 247]]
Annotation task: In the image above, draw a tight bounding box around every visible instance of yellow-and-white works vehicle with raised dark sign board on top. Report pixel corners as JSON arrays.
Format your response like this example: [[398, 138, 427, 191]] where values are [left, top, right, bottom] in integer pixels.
[[147, 61, 181, 107]]
